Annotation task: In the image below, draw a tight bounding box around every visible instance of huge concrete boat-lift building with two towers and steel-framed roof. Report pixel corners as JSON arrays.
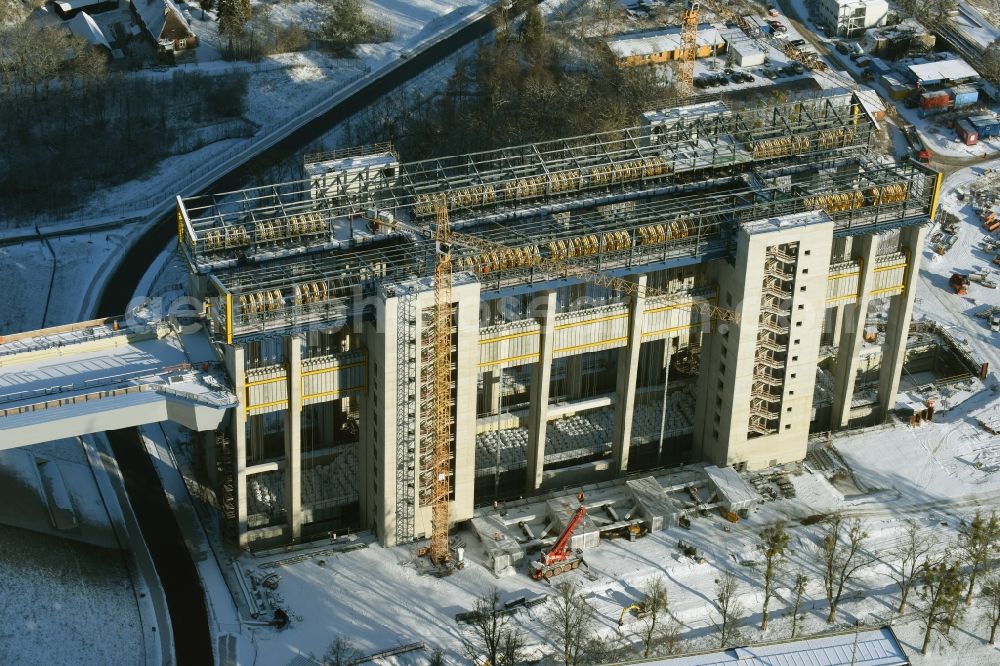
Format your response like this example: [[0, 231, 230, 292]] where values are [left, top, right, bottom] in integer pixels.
[[164, 94, 940, 548]]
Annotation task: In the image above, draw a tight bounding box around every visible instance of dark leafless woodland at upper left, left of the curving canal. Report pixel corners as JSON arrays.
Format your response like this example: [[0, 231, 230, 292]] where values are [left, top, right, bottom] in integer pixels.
[[0, 73, 249, 220]]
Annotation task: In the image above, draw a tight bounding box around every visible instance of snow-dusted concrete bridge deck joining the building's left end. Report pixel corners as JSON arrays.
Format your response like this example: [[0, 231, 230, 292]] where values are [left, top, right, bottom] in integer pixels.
[[0, 319, 236, 449]]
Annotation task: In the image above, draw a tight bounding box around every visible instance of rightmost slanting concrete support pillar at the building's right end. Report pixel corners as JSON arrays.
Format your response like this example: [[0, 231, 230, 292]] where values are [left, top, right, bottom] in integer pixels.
[[878, 225, 927, 419]]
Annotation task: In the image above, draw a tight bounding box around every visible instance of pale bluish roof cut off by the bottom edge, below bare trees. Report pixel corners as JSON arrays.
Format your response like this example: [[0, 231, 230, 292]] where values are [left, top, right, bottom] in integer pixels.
[[642, 627, 910, 666]]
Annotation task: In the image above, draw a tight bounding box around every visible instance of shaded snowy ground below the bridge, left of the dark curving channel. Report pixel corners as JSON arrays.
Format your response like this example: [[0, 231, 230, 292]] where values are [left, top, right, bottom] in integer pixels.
[[0, 439, 148, 664]]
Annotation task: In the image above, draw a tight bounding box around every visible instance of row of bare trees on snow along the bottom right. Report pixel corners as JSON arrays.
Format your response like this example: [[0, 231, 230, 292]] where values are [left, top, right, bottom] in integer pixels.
[[316, 512, 1000, 666]]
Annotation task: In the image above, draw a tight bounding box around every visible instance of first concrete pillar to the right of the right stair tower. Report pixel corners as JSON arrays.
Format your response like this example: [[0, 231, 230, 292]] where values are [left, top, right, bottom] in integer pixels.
[[830, 234, 878, 430]]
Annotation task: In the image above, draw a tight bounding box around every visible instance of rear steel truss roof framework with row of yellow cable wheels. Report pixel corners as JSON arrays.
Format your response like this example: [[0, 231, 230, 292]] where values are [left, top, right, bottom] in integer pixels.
[[178, 95, 872, 273]]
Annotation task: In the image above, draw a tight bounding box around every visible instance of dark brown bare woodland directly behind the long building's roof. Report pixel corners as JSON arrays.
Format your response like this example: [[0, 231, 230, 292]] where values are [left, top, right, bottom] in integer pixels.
[[346, 3, 672, 161]]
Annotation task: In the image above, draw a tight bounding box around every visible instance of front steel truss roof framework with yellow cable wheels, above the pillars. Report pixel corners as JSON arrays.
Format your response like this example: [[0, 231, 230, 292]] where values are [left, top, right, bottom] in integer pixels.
[[205, 155, 939, 339]]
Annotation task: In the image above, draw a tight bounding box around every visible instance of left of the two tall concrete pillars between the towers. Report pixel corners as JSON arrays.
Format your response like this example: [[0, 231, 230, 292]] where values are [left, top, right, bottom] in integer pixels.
[[525, 290, 556, 495]]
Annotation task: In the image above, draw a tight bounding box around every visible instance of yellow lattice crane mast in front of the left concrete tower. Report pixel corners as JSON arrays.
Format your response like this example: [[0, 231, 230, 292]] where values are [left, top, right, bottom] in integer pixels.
[[430, 200, 452, 564]]
